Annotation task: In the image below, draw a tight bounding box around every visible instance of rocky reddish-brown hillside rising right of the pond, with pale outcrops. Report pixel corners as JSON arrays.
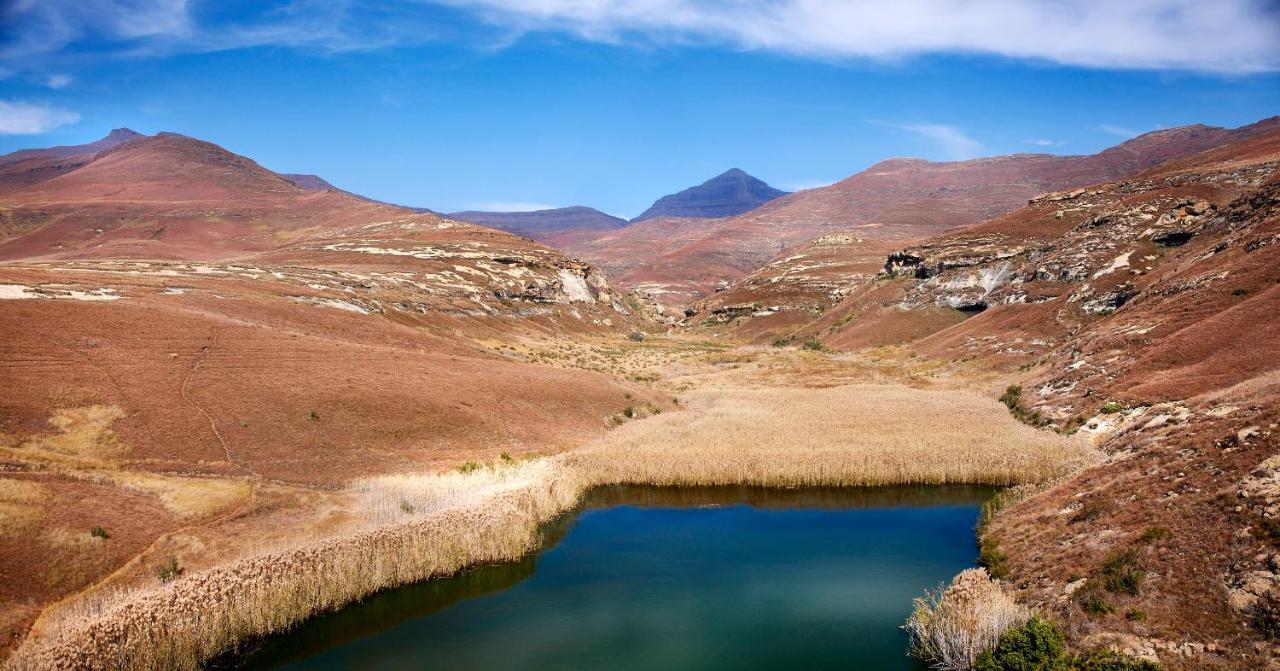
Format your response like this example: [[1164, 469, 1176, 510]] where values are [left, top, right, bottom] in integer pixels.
[[695, 120, 1280, 668]]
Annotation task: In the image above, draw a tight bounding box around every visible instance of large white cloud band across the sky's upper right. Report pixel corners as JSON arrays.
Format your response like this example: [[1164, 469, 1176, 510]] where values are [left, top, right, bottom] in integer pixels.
[[440, 0, 1280, 73]]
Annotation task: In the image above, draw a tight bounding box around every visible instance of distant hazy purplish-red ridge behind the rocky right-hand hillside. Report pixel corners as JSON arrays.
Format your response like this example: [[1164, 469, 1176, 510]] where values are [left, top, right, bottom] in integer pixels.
[[576, 124, 1260, 303]]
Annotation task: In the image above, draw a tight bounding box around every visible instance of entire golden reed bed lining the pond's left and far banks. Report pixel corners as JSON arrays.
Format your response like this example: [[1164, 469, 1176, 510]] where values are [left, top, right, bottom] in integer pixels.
[[8, 385, 1094, 670]]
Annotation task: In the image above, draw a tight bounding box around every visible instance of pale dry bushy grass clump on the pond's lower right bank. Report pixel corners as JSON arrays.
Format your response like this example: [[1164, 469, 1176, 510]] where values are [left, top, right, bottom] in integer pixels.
[[904, 569, 1032, 671]]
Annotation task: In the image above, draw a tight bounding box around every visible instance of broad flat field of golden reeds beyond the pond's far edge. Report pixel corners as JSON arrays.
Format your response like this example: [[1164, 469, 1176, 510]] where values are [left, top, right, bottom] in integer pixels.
[[576, 385, 1097, 487]]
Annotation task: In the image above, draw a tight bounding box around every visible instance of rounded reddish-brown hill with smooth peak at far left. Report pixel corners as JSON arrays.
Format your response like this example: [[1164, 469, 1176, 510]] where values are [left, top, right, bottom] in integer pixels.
[[0, 133, 424, 260]]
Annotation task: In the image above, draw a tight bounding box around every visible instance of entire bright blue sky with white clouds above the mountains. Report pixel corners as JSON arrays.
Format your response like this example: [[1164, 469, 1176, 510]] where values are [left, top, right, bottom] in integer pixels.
[[0, 0, 1280, 216]]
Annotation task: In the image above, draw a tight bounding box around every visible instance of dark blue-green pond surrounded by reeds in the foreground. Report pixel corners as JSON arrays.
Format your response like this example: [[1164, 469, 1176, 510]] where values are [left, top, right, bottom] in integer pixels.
[[227, 487, 992, 671]]
